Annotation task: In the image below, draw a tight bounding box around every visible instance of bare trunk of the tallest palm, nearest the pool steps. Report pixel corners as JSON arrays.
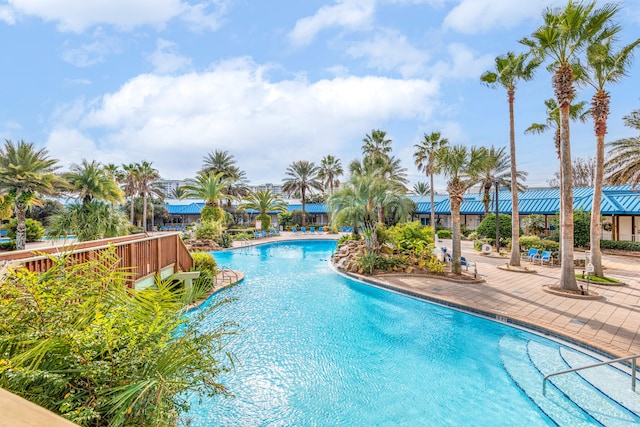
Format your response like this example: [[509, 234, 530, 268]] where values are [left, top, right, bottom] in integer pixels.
[[560, 102, 578, 291]]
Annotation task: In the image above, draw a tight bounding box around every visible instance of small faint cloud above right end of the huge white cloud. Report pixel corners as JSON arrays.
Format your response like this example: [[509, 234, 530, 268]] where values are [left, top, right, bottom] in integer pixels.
[[347, 30, 429, 77]]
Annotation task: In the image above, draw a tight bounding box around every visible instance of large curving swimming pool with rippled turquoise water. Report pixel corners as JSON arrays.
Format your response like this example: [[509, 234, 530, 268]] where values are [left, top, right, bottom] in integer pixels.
[[188, 241, 639, 426]]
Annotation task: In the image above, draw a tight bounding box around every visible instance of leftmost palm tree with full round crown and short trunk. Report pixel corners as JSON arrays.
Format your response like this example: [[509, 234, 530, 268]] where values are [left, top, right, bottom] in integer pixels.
[[0, 140, 66, 250]]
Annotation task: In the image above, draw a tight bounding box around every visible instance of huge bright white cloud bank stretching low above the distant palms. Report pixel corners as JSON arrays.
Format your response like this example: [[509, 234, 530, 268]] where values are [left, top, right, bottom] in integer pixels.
[[49, 59, 438, 182]]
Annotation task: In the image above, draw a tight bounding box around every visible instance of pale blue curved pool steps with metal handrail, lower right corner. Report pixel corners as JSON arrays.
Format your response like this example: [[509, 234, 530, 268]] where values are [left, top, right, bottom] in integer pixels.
[[499, 336, 640, 427]]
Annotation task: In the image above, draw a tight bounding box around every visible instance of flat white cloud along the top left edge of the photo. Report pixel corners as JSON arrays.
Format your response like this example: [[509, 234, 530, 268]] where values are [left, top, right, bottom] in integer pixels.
[[5, 0, 228, 33]]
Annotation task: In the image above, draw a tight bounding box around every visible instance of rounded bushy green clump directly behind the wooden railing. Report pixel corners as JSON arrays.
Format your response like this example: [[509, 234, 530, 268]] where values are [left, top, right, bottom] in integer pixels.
[[48, 200, 130, 242]]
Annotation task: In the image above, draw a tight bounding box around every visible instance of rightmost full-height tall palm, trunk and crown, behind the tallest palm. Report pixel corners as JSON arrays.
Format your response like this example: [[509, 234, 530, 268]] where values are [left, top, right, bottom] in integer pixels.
[[587, 30, 640, 277]]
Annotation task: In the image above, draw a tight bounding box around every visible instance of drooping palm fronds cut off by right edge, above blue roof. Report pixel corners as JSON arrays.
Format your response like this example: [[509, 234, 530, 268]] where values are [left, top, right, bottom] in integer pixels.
[[605, 110, 640, 186]]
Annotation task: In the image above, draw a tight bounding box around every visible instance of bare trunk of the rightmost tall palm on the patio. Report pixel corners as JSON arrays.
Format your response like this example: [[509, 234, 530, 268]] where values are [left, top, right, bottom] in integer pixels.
[[589, 90, 609, 277]]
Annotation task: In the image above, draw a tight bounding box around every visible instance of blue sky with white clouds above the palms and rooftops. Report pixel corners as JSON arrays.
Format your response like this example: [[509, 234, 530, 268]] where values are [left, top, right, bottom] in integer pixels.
[[0, 0, 640, 191]]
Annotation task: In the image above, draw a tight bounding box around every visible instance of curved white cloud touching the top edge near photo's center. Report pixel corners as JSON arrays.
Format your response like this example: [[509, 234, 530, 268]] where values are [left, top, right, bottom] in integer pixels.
[[289, 0, 375, 46]]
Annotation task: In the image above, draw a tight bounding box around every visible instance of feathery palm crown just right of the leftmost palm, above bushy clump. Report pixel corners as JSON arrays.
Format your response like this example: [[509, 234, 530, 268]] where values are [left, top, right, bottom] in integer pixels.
[[63, 159, 124, 208]]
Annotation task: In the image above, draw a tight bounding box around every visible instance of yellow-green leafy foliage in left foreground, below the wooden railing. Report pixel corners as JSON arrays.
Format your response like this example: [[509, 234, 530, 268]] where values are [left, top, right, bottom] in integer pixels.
[[0, 249, 233, 427]]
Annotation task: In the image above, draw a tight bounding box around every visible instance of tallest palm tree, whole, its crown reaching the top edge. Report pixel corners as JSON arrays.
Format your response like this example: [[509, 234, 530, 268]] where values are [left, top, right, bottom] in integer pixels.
[[521, 0, 617, 291]]
